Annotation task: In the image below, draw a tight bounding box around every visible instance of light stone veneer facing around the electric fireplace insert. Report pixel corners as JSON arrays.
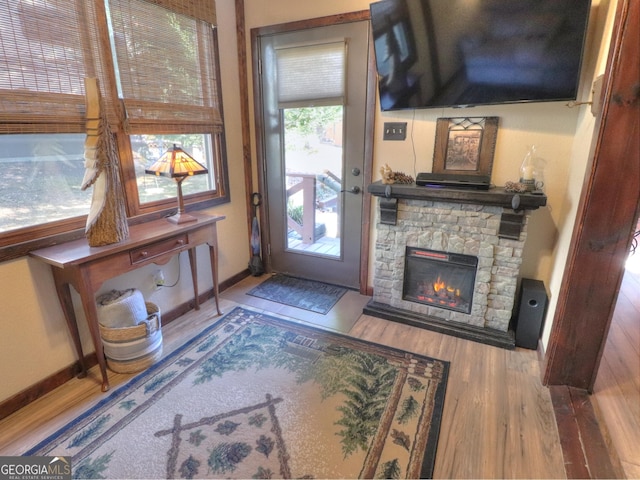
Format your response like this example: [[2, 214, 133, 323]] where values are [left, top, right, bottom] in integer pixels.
[[373, 198, 528, 332]]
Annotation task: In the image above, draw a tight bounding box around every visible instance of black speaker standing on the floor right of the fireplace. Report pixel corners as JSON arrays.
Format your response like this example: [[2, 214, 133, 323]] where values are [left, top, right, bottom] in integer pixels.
[[515, 278, 548, 350]]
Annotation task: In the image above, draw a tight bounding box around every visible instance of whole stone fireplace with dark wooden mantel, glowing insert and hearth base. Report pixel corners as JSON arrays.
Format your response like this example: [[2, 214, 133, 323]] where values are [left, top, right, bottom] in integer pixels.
[[365, 184, 546, 348]]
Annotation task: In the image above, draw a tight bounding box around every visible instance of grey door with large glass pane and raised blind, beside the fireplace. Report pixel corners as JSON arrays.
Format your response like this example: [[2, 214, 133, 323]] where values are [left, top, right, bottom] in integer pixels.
[[254, 15, 369, 288]]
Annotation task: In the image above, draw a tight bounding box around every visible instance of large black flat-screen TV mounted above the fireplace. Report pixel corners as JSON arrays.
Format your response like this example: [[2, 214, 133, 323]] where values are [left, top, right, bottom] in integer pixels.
[[370, 0, 591, 111]]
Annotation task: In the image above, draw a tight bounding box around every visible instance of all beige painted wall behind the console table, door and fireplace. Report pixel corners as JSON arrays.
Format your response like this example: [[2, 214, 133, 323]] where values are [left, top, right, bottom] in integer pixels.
[[0, 0, 610, 402]]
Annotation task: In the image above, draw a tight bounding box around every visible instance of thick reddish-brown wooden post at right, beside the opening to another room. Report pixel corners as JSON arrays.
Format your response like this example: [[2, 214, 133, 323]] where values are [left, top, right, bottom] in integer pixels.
[[543, 0, 640, 391]]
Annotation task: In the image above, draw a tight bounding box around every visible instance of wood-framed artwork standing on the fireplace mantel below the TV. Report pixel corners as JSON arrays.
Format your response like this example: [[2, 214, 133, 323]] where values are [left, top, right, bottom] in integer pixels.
[[433, 117, 498, 177]]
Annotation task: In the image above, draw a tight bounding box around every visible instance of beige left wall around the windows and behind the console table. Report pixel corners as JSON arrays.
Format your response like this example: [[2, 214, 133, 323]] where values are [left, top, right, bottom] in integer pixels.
[[0, 0, 250, 402]]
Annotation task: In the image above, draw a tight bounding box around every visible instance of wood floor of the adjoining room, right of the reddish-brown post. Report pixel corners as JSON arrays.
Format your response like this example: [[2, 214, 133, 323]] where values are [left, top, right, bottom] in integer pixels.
[[593, 250, 640, 478]]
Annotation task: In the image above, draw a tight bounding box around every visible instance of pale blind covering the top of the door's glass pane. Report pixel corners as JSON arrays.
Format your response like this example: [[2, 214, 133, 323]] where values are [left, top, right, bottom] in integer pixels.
[[276, 40, 347, 108]]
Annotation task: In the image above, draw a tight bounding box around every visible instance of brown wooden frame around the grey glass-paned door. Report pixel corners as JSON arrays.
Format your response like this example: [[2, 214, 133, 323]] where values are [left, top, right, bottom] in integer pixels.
[[251, 10, 376, 295]]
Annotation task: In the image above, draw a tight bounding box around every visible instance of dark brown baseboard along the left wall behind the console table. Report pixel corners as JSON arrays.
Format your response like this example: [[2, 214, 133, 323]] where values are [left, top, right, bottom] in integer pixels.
[[0, 269, 251, 420]]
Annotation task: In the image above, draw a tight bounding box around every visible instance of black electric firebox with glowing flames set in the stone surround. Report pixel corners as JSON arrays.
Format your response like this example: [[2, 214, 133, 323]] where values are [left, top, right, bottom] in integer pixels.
[[402, 246, 478, 314]]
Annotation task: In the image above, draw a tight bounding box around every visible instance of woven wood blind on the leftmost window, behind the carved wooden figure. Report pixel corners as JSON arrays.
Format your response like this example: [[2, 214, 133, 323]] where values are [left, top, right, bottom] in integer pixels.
[[0, 0, 96, 133]]
